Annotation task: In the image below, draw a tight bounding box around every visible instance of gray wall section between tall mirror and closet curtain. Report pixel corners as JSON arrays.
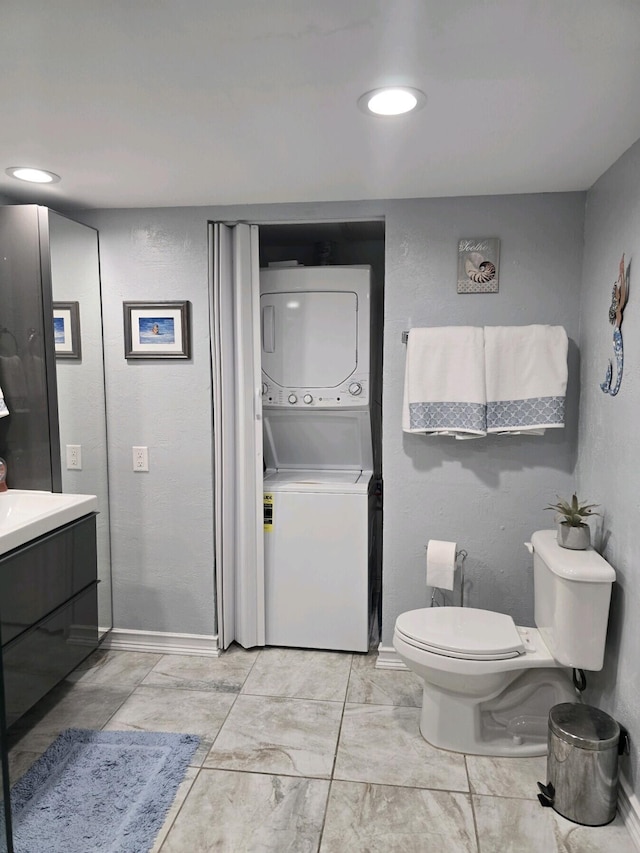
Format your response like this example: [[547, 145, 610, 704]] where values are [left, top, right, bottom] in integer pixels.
[[74, 209, 215, 634]]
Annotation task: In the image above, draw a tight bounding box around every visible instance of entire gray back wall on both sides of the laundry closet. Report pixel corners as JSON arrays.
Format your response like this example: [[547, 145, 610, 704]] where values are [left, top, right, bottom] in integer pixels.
[[80, 193, 584, 645]]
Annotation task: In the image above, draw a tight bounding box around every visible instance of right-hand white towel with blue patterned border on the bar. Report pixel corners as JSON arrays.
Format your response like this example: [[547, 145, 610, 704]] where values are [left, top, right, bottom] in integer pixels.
[[484, 326, 569, 435]]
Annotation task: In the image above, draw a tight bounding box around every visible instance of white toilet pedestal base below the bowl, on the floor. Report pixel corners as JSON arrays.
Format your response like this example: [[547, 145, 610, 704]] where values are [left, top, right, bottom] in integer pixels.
[[420, 669, 576, 757]]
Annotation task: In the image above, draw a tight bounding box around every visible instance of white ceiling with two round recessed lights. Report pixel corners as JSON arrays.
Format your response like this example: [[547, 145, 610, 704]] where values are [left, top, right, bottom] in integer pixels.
[[0, 0, 640, 207]]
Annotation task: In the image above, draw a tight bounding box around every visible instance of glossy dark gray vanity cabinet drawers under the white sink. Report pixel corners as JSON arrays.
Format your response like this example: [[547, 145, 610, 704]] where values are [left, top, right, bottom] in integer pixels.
[[0, 514, 98, 726]]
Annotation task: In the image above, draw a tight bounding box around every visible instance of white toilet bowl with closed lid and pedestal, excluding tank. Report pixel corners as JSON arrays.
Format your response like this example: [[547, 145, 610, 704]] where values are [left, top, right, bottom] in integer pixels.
[[393, 607, 576, 756]]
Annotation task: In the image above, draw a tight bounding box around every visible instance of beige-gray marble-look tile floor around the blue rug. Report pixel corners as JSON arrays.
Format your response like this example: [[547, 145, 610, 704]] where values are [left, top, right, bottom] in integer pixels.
[[10, 647, 636, 853]]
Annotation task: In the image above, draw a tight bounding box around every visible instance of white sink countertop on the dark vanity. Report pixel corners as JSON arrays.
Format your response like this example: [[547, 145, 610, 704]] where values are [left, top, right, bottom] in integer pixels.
[[0, 489, 98, 555]]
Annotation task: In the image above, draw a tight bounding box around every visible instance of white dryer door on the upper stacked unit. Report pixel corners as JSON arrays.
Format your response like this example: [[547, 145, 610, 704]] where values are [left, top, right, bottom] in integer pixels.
[[260, 291, 358, 392]]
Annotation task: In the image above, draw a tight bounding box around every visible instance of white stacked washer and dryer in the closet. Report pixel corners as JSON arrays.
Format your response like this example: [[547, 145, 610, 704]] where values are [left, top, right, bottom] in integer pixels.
[[260, 266, 376, 652]]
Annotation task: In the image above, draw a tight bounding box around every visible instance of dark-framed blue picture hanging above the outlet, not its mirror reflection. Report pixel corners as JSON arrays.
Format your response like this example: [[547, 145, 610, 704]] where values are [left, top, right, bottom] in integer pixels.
[[123, 302, 191, 359]]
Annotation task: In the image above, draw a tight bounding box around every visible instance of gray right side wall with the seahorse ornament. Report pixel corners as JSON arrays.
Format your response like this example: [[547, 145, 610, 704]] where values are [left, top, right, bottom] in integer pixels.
[[577, 136, 640, 795]]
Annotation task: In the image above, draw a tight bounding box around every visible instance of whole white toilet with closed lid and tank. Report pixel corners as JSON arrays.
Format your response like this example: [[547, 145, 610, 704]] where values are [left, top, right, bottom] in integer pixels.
[[393, 530, 615, 756]]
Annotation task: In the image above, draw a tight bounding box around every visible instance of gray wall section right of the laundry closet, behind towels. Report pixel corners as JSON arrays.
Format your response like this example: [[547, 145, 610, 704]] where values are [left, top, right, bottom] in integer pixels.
[[382, 193, 584, 645]]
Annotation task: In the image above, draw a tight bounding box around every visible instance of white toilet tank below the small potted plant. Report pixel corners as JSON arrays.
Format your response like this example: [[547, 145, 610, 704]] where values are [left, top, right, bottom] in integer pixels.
[[531, 530, 616, 671]]
